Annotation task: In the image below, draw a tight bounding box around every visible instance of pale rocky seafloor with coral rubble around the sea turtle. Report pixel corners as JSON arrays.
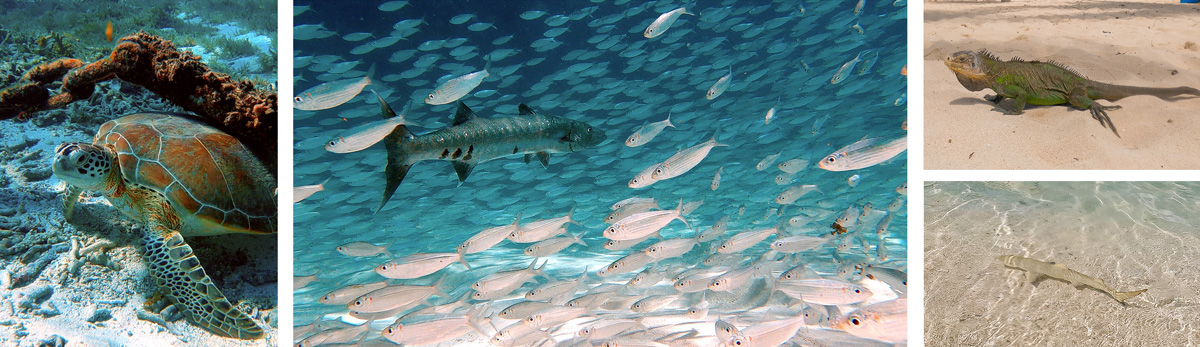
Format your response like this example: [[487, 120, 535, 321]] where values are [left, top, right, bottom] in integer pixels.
[[0, 21, 278, 346]]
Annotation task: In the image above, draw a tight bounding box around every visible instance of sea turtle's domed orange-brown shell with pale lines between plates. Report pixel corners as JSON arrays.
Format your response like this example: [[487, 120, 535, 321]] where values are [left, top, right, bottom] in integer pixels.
[[92, 113, 277, 235]]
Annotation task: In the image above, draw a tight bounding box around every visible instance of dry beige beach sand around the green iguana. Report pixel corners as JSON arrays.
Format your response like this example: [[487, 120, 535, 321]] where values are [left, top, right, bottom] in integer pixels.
[[924, 0, 1200, 169]]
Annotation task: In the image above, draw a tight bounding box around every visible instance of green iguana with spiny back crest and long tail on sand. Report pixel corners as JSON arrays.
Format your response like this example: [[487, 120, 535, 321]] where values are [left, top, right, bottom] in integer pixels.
[[946, 50, 1200, 137]]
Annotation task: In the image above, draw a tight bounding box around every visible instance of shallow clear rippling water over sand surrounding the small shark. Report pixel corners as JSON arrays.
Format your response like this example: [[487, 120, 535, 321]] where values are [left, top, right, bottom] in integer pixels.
[[925, 183, 1200, 346]]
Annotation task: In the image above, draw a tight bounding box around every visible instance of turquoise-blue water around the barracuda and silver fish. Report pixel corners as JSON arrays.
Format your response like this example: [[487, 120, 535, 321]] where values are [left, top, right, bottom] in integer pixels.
[[293, 1, 907, 336]]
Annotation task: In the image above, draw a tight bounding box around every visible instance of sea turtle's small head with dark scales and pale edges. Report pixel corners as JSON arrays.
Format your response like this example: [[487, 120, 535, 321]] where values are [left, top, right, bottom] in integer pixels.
[[54, 142, 113, 191]]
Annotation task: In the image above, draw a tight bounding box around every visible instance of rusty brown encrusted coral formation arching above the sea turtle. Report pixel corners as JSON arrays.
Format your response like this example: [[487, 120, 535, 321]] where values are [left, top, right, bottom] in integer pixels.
[[0, 32, 278, 165]]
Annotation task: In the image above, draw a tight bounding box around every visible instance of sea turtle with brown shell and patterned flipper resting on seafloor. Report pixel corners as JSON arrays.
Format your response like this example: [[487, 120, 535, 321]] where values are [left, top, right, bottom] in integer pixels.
[[54, 113, 277, 340]]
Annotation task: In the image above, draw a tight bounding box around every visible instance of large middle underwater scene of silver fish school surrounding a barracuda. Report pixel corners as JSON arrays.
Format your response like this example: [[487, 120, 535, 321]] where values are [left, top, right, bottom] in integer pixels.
[[293, 0, 907, 347]]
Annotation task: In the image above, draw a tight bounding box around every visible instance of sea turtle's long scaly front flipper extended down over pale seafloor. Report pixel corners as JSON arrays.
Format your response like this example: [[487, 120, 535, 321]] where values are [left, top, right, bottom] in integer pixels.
[[142, 223, 263, 340]]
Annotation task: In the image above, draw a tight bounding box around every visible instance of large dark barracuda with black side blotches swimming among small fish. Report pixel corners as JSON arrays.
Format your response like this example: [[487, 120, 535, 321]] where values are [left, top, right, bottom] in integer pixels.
[[376, 101, 605, 211]]
